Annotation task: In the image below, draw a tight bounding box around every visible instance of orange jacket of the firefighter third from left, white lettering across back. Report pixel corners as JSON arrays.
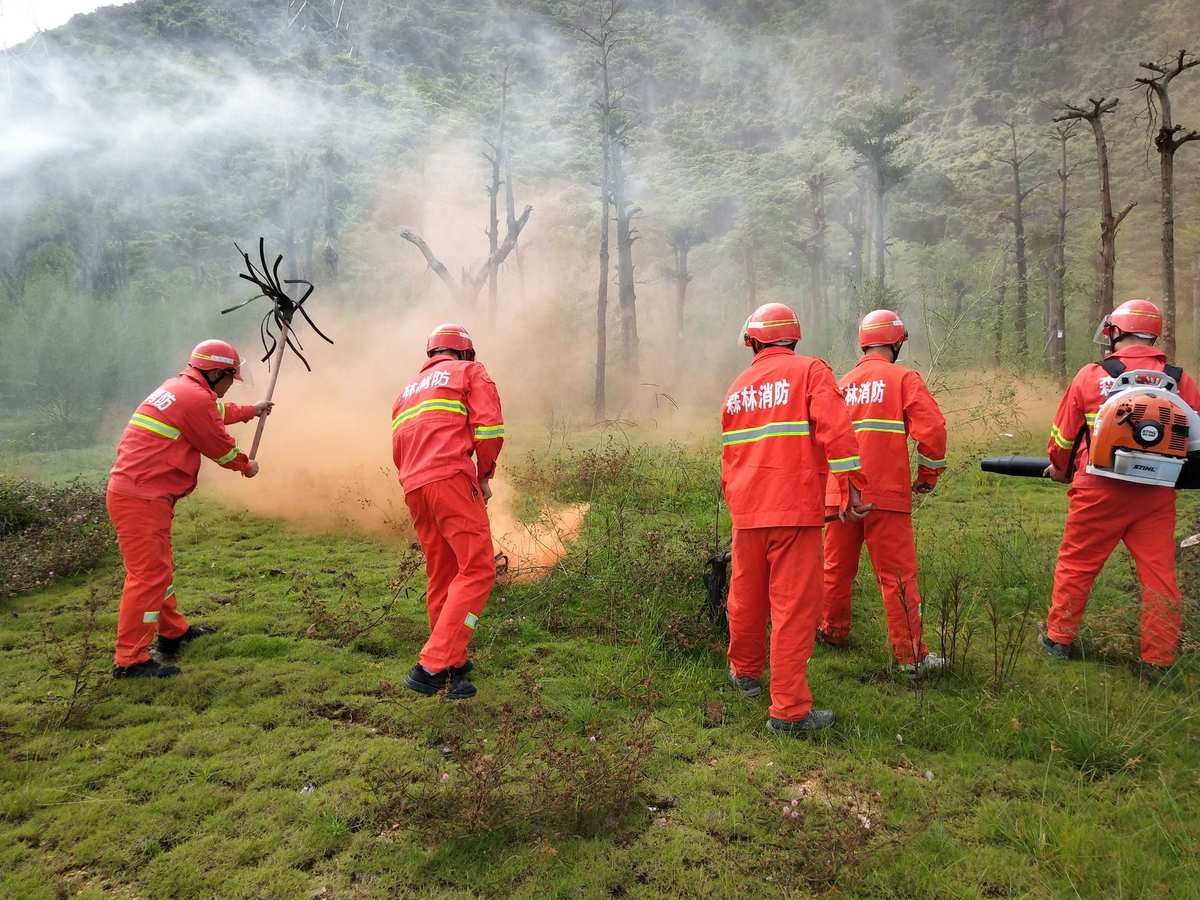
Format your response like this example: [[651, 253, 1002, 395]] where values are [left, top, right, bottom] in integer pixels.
[[721, 347, 866, 528]]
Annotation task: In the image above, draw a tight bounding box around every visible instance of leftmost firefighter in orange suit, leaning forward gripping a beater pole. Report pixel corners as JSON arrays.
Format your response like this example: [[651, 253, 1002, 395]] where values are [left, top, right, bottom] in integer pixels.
[[106, 341, 274, 678]]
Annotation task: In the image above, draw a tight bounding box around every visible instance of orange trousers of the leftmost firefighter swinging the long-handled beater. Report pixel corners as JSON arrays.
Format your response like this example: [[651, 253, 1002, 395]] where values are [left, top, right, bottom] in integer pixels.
[[104, 491, 187, 666]]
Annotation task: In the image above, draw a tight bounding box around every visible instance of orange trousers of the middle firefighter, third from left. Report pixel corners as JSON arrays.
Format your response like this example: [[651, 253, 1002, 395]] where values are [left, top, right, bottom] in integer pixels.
[[728, 526, 822, 721]]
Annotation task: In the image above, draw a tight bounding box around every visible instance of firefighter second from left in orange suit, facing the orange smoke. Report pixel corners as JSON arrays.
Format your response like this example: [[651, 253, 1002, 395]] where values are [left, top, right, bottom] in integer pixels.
[[391, 323, 504, 700]]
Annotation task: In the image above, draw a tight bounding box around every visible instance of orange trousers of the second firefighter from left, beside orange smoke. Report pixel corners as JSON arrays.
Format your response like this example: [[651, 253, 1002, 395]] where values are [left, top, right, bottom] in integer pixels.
[[404, 473, 496, 672]]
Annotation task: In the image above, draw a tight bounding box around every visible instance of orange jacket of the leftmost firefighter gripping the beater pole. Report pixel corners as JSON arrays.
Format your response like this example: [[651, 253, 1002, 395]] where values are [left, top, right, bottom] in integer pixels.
[[108, 368, 254, 502]]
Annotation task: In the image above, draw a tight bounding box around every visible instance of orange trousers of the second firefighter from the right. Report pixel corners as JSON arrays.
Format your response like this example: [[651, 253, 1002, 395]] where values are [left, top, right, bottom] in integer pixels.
[[821, 509, 929, 665]]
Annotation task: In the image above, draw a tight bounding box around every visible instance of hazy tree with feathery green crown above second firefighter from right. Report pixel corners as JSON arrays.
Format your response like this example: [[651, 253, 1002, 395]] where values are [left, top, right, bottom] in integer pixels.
[[838, 95, 917, 290]]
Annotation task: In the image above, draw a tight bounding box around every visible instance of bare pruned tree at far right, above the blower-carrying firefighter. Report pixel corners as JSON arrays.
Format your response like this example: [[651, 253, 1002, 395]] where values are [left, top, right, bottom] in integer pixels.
[[1135, 50, 1200, 358]]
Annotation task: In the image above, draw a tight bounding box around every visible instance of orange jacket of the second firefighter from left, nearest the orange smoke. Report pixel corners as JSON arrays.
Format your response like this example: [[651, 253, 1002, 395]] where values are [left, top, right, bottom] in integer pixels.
[[391, 356, 504, 492]]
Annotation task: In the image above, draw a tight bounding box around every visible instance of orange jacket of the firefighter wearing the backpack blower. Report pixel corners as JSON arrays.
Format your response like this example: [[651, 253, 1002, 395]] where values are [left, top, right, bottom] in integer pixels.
[[1046, 344, 1200, 492]]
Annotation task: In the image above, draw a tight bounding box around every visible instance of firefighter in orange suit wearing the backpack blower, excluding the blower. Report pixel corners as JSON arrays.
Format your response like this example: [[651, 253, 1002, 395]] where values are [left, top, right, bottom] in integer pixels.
[[1040, 300, 1200, 677]]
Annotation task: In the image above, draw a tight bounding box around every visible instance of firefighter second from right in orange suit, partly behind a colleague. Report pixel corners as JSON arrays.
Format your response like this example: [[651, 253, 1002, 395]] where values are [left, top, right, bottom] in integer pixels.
[[817, 310, 946, 674]]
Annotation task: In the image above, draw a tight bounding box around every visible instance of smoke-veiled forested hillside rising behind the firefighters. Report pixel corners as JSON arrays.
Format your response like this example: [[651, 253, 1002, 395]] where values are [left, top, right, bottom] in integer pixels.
[[0, 0, 1200, 439]]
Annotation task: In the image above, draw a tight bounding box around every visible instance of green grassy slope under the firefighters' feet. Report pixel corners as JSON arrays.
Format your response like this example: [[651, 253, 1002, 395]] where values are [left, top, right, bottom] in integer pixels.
[[0, 442, 1200, 896]]
